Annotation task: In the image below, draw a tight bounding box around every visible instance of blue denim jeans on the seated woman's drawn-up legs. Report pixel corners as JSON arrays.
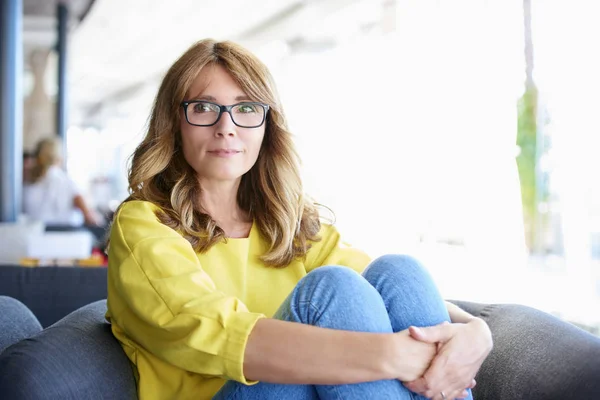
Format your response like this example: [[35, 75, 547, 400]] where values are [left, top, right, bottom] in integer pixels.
[[213, 255, 472, 400]]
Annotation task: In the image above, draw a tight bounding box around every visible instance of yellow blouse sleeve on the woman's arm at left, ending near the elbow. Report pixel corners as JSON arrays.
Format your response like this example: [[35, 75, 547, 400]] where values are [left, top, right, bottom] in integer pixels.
[[108, 201, 264, 384]]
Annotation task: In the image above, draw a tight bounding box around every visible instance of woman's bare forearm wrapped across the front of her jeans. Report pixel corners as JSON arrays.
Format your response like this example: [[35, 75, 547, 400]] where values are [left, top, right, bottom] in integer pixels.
[[244, 318, 435, 384]]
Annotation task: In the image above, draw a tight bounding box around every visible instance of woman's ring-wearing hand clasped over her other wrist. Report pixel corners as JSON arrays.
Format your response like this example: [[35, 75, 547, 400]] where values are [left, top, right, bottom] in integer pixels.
[[404, 318, 492, 400]]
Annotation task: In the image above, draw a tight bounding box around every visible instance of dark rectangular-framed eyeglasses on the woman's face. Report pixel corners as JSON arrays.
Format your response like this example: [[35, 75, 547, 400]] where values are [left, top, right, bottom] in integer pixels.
[[181, 100, 269, 128]]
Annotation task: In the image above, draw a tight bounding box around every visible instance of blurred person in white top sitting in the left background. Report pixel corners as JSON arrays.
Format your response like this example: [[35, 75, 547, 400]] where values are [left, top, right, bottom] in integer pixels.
[[23, 137, 101, 226]]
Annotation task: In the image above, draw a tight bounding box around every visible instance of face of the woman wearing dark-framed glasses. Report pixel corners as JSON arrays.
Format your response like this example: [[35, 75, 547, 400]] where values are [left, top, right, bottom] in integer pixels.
[[181, 65, 266, 181]]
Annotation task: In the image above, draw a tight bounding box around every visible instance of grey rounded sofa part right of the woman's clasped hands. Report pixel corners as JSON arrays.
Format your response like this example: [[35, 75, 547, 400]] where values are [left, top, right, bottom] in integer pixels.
[[452, 300, 600, 400]]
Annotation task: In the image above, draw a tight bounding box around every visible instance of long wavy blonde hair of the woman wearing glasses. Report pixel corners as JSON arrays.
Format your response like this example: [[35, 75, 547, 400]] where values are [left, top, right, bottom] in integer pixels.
[[126, 39, 320, 267]]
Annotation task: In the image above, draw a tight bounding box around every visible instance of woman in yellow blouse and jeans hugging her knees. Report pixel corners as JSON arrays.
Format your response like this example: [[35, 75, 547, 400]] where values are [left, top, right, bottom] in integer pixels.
[[107, 40, 491, 400]]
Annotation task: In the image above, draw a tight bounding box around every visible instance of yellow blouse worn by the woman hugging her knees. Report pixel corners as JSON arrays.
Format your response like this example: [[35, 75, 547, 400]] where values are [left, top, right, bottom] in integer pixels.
[[106, 201, 370, 400]]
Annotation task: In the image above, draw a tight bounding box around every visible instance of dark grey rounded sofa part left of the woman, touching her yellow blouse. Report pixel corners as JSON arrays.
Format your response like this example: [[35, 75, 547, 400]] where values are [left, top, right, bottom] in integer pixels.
[[0, 300, 137, 400]]
